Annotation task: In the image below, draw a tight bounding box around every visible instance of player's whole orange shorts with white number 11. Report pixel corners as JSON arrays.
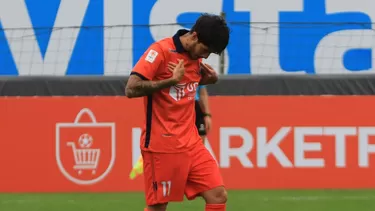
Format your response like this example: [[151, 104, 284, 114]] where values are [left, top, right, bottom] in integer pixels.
[[142, 144, 224, 205]]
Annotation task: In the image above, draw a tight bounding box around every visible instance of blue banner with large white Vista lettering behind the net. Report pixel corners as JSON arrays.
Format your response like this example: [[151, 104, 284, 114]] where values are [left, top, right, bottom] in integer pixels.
[[0, 0, 375, 76]]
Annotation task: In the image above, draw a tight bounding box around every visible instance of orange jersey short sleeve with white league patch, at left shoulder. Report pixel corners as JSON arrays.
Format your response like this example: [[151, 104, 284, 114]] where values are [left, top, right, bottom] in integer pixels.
[[131, 43, 164, 80]]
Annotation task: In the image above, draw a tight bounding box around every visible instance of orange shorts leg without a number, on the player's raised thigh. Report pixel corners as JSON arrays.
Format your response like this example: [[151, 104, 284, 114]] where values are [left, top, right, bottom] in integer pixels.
[[185, 144, 224, 200]]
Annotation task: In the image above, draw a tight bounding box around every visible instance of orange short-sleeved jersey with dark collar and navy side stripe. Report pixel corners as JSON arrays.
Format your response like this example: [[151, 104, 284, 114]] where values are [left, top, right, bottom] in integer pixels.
[[131, 30, 201, 153]]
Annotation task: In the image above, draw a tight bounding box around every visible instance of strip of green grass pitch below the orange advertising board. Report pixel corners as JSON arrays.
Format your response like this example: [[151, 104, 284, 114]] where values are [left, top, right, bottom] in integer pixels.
[[0, 190, 375, 211]]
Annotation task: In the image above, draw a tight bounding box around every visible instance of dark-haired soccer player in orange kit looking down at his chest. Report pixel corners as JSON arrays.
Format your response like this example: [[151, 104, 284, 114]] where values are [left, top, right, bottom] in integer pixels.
[[125, 14, 229, 211]]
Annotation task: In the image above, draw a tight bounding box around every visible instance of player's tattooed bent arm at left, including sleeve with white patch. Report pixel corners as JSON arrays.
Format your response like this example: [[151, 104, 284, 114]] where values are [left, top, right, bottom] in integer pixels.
[[125, 44, 185, 98]]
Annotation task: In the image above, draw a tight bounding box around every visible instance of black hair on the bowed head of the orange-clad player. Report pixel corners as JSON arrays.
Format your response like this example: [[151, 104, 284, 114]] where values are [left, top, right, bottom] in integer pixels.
[[190, 13, 229, 54]]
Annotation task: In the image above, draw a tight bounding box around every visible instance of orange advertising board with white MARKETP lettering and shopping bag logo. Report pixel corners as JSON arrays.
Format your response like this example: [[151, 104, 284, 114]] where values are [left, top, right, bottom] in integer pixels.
[[0, 96, 375, 192]]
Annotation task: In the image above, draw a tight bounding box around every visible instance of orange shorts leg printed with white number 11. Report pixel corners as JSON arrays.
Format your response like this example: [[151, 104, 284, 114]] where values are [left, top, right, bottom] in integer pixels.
[[142, 151, 189, 205]]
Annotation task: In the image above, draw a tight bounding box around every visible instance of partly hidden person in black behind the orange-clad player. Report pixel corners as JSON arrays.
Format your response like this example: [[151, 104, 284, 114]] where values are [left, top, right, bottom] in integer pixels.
[[195, 85, 211, 142]]
